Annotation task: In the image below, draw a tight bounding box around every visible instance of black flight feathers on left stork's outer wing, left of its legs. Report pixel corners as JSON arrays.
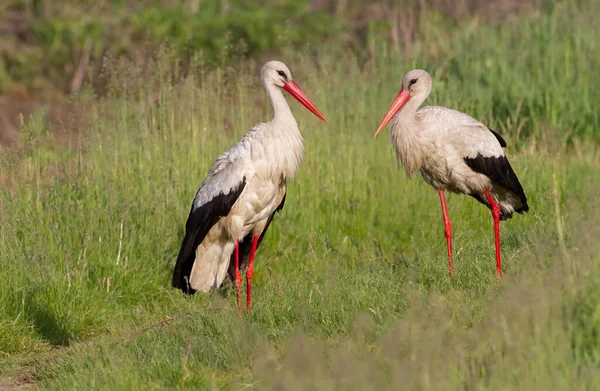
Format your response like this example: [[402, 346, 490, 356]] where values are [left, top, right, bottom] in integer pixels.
[[171, 177, 246, 294]]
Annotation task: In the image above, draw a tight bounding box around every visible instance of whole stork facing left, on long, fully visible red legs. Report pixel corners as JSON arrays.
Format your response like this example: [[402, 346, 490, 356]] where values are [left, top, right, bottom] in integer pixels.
[[375, 69, 529, 278]]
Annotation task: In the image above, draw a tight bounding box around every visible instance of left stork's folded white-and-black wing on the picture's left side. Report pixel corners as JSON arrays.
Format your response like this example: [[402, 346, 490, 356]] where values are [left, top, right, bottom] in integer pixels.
[[172, 151, 251, 293]]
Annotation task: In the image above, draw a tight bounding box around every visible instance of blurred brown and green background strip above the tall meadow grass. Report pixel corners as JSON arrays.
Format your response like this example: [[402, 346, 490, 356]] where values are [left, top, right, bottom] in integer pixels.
[[0, 0, 580, 145]]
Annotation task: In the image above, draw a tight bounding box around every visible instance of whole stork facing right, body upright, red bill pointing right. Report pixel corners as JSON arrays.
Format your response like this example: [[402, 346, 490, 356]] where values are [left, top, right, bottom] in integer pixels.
[[172, 61, 327, 310]]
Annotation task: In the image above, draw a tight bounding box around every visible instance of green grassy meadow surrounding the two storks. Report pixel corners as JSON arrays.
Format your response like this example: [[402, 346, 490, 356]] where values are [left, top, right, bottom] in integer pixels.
[[0, 3, 600, 389]]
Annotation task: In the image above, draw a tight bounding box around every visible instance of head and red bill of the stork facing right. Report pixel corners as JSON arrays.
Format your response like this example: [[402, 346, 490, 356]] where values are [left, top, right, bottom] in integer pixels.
[[260, 61, 327, 122]]
